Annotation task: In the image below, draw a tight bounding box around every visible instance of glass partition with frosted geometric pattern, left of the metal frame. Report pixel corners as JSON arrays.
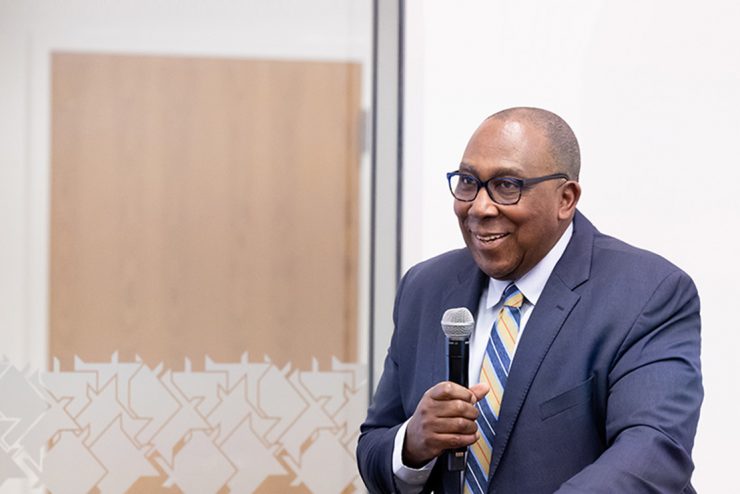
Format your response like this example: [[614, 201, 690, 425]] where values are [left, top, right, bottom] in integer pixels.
[[0, 0, 395, 494]]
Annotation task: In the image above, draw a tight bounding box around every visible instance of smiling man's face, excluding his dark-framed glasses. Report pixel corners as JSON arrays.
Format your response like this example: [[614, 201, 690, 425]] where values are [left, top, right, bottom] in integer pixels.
[[454, 115, 577, 280]]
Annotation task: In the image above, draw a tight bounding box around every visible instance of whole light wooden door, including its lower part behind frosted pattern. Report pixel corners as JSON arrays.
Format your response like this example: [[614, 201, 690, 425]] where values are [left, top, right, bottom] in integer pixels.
[[48, 53, 367, 493]]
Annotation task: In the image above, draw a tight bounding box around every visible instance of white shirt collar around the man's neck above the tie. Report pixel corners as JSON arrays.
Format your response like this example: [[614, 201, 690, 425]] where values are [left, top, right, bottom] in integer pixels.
[[486, 221, 573, 309]]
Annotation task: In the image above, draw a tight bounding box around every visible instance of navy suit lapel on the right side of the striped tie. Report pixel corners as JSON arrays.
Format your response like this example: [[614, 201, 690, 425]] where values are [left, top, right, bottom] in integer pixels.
[[490, 212, 595, 476]]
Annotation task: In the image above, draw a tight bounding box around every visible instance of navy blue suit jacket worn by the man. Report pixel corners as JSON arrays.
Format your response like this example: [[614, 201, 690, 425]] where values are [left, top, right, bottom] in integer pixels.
[[357, 213, 703, 494]]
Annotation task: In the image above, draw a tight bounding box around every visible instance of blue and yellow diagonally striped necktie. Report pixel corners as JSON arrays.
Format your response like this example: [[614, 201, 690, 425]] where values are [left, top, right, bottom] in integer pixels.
[[465, 283, 524, 494]]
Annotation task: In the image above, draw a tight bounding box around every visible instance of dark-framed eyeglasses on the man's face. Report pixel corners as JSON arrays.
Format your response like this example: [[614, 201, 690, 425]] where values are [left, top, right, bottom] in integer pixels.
[[447, 172, 569, 206]]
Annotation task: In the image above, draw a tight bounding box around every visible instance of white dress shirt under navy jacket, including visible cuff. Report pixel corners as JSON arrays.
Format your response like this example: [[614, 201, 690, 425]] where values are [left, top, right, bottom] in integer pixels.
[[393, 223, 573, 494]]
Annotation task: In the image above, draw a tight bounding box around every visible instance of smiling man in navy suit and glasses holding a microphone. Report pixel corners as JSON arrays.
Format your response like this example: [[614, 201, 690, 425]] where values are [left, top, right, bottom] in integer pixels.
[[357, 108, 703, 494]]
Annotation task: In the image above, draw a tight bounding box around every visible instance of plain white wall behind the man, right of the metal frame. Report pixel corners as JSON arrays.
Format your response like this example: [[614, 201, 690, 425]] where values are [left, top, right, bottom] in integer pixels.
[[403, 0, 740, 486]]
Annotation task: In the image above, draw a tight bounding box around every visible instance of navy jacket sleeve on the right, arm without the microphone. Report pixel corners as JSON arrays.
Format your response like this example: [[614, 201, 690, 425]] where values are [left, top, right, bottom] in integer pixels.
[[557, 271, 703, 494]]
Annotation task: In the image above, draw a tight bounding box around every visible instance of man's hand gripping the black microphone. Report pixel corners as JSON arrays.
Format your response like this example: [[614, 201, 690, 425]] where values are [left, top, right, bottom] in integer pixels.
[[402, 381, 488, 468]]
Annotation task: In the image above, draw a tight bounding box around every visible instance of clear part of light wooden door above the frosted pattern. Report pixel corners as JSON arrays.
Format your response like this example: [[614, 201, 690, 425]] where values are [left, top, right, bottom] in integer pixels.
[[49, 53, 360, 369]]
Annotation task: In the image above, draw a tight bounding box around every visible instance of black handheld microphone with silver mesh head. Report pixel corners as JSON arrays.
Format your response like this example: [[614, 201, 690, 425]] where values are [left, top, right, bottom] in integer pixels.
[[442, 307, 475, 472]]
